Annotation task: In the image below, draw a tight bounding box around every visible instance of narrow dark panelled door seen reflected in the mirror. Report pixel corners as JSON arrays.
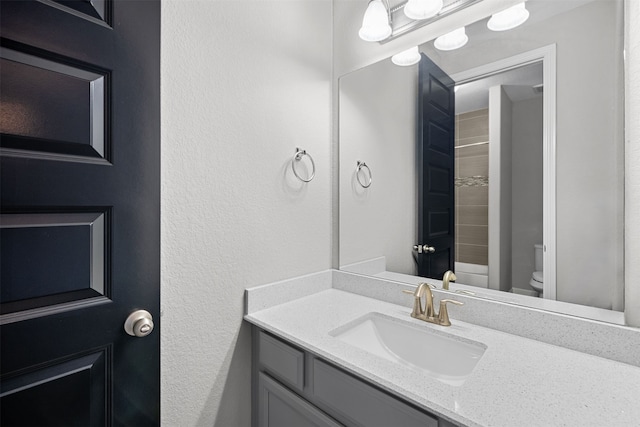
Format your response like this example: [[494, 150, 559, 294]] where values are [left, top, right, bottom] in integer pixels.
[[416, 54, 455, 279]]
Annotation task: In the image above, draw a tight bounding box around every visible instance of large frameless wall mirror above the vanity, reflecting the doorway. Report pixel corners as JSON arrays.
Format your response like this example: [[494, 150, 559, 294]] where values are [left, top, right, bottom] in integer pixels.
[[339, 0, 624, 323]]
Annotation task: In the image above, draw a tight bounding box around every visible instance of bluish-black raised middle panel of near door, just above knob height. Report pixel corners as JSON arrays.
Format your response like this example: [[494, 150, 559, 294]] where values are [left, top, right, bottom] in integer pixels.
[[0, 212, 105, 306]]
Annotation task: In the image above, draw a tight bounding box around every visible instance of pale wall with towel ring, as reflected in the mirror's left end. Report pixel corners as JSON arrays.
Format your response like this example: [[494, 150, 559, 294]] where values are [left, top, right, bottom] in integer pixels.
[[339, 60, 418, 274]]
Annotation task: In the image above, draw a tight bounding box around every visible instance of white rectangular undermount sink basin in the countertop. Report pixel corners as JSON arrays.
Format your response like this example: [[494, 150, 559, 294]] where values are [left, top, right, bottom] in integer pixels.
[[330, 313, 487, 386]]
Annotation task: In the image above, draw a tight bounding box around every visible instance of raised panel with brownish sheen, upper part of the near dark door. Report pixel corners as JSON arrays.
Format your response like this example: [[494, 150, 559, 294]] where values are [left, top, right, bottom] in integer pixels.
[[0, 43, 106, 158]]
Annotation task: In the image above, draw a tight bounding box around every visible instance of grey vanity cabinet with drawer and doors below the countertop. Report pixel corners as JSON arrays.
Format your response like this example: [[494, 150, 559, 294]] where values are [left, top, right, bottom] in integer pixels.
[[252, 326, 454, 427]]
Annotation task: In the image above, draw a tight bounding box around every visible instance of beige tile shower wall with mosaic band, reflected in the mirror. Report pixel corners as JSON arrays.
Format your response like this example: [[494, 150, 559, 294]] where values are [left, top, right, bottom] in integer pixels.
[[455, 109, 489, 265]]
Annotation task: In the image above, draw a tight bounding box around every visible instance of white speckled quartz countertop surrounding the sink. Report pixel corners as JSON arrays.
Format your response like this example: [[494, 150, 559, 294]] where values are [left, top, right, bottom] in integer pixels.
[[245, 289, 640, 426]]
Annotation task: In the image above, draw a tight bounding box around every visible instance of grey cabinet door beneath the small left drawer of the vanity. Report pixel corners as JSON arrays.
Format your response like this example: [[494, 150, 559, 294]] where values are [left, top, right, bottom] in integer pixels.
[[258, 372, 340, 427]]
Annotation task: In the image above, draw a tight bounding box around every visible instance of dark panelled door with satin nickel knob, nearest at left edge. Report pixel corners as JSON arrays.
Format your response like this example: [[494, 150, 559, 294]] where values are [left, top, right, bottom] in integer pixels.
[[0, 0, 160, 426]]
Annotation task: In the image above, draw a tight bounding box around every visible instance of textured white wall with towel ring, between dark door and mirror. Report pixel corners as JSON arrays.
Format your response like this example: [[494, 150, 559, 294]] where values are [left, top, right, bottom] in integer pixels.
[[161, 0, 332, 427]]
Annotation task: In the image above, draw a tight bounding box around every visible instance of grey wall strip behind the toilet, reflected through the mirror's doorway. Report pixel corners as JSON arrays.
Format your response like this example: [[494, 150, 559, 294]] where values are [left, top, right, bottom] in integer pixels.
[[511, 97, 542, 291]]
